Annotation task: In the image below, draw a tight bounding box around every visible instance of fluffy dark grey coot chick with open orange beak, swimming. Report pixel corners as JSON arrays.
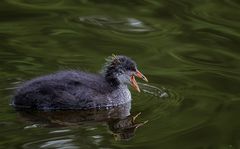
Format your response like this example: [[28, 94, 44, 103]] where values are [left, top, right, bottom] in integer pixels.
[[12, 55, 147, 110]]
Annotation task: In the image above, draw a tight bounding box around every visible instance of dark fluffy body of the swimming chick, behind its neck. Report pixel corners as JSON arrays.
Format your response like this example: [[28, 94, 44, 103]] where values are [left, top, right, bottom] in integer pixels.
[[12, 71, 121, 109]]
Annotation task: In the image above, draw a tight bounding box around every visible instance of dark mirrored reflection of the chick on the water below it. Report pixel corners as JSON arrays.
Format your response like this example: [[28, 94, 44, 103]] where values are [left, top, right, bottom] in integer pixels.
[[17, 103, 148, 140]]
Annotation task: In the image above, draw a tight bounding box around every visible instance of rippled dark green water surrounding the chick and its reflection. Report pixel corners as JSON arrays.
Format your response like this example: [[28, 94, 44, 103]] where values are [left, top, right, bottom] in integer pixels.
[[0, 0, 240, 149]]
